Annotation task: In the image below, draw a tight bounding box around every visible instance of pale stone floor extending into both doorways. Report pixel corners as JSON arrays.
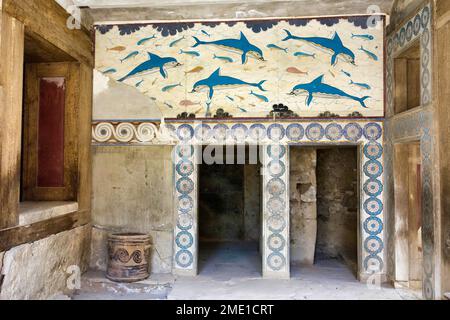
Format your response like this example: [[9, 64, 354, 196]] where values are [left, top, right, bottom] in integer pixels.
[[73, 243, 416, 300]]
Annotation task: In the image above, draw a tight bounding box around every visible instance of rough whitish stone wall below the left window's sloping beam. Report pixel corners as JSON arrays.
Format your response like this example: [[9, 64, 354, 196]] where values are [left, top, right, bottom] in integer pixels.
[[0, 225, 91, 300]]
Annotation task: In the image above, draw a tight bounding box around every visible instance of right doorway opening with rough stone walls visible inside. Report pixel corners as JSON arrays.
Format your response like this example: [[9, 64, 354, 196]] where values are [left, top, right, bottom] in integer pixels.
[[290, 146, 359, 279]]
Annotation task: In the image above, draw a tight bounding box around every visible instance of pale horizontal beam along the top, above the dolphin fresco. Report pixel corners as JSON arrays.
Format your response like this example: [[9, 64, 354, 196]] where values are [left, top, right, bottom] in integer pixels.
[[83, 0, 396, 22]]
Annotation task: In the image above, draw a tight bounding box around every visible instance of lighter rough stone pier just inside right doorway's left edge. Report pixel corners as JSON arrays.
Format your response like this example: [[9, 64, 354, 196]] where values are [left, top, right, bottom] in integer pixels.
[[290, 147, 317, 265]]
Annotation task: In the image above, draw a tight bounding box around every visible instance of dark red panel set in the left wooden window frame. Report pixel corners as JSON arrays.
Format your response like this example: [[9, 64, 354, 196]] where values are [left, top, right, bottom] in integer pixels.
[[37, 78, 66, 188]]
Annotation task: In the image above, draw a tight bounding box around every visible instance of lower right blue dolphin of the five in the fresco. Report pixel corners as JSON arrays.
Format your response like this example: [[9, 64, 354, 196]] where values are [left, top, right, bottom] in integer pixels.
[[291, 75, 370, 108]]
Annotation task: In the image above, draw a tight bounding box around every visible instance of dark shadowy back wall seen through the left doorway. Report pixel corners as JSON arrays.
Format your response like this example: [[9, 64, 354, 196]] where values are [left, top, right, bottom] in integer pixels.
[[199, 161, 261, 241]]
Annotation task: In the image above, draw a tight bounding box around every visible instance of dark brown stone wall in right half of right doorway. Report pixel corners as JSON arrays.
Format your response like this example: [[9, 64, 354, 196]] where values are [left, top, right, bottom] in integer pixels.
[[316, 148, 358, 270]]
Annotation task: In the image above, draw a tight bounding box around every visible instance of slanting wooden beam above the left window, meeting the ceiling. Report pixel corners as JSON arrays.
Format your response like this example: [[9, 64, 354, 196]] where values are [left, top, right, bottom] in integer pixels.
[[3, 0, 94, 67]]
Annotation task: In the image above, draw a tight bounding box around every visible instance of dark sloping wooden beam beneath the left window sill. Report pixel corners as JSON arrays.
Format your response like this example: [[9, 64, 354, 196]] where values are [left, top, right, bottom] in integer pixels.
[[0, 211, 90, 252]]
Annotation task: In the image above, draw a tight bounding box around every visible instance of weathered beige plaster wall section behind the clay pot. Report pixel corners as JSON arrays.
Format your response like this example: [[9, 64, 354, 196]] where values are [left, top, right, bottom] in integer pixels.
[[91, 146, 174, 273]]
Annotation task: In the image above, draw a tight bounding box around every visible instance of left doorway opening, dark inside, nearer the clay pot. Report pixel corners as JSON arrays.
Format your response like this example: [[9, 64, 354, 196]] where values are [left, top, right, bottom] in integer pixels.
[[199, 146, 262, 277]]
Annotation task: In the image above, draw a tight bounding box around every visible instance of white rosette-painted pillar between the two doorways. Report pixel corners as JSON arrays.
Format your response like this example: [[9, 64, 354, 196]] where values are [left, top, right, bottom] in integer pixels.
[[262, 144, 290, 279]]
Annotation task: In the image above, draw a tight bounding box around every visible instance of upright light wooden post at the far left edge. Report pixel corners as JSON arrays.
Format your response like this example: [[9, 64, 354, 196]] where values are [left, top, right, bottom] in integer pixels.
[[0, 13, 25, 229]]
